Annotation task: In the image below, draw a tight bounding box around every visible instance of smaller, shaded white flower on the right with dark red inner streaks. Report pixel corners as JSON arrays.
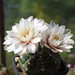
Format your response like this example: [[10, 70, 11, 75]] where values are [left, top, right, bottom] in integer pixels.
[[42, 21, 74, 52]]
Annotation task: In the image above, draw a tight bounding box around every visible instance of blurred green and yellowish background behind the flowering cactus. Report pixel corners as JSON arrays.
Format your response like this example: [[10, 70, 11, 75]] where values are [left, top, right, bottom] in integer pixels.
[[0, 0, 75, 74]]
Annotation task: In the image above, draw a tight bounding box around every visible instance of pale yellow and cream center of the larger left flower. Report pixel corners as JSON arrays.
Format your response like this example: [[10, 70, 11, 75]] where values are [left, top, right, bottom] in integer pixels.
[[19, 28, 33, 43]]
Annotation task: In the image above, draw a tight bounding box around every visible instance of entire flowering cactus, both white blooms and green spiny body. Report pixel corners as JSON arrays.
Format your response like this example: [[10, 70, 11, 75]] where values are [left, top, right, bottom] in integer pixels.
[[3, 16, 74, 75]]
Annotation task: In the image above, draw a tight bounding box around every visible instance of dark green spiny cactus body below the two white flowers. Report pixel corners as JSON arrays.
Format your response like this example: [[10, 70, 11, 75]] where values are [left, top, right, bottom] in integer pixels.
[[19, 47, 61, 75]]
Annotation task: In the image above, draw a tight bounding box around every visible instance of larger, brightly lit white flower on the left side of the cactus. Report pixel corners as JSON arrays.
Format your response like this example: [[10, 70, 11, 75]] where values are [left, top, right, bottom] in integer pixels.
[[4, 16, 46, 55]]
